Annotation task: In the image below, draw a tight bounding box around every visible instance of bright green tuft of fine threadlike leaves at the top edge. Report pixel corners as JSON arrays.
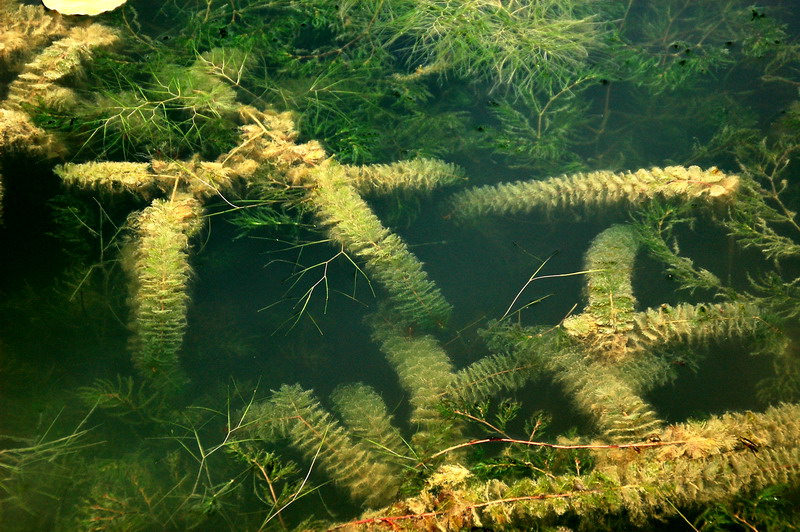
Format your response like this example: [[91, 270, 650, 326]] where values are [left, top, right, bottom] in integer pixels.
[[341, 0, 601, 93]]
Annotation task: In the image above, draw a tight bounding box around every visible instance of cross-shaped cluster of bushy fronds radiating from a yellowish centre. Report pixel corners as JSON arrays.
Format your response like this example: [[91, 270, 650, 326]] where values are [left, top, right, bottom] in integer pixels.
[[466, 226, 786, 442]]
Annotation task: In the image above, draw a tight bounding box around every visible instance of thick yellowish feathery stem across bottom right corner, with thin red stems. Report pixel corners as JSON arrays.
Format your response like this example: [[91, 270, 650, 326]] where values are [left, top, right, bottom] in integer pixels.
[[337, 405, 800, 530]]
